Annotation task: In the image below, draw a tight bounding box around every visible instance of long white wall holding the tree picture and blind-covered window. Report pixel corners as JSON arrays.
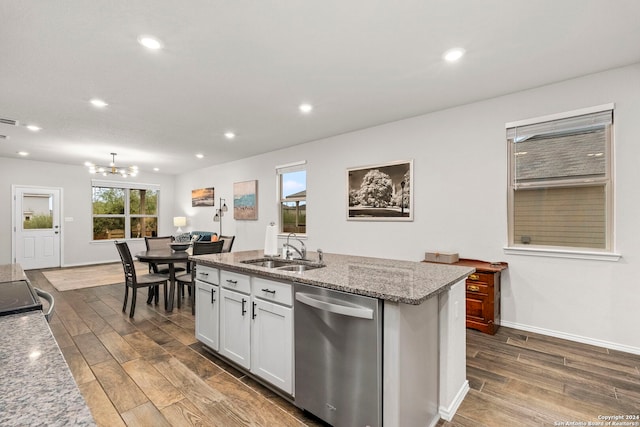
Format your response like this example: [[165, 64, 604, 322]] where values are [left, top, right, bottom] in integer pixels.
[[175, 65, 640, 353]]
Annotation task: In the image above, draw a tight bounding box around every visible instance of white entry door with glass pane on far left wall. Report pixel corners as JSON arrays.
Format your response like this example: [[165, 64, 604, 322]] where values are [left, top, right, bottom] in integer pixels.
[[13, 186, 61, 270]]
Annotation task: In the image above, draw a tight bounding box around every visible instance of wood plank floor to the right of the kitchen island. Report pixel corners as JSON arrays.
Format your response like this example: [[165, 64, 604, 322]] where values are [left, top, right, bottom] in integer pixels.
[[438, 327, 640, 427]]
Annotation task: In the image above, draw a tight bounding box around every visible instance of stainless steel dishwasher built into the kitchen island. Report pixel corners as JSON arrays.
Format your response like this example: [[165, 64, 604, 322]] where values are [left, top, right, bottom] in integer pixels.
[[294, 284, 382, 427]]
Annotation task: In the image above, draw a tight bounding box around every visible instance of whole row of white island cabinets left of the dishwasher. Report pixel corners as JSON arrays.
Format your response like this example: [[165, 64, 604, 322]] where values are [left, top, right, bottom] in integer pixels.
[[196, 267, 293, 395]]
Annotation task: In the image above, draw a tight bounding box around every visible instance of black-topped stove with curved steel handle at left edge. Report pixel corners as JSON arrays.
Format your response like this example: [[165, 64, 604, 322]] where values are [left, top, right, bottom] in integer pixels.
[[0, 280, 54, 321]]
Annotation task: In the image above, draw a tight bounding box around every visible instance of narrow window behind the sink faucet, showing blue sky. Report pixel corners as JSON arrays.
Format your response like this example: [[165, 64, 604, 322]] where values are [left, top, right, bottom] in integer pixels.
[[276, 162, 307, 234]]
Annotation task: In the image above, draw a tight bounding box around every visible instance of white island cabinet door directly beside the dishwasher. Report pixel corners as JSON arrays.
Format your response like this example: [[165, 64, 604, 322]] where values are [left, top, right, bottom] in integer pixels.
[[251, 298, 293, 394]]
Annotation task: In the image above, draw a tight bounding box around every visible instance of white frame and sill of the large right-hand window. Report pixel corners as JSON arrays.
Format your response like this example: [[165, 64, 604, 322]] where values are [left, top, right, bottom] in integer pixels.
[[504, 103, 621, 261]]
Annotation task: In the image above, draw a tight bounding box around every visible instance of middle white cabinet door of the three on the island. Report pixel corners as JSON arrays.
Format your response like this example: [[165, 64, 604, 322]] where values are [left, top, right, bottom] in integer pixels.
[[220, 288, 251, 369]]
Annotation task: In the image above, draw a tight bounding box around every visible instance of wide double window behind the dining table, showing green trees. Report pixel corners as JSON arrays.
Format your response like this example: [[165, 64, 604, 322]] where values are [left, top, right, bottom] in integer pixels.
[[91, 180, 160, 240]]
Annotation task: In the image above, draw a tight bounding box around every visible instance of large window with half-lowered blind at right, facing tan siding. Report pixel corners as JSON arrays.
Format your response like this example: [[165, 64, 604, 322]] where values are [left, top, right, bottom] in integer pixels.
[[507, 105, 613, 252]]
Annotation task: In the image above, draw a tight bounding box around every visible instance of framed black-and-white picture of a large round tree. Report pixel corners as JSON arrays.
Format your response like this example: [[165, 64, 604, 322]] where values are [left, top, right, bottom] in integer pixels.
[[347, 160, 413, 221]]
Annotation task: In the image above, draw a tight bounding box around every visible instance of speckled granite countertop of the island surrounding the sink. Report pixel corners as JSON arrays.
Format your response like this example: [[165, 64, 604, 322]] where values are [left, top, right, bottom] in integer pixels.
[[190, 250, 475, 305]]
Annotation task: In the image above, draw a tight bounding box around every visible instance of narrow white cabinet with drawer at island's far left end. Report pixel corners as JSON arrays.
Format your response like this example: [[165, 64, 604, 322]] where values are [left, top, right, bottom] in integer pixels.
[[195, 265, 220, 351]]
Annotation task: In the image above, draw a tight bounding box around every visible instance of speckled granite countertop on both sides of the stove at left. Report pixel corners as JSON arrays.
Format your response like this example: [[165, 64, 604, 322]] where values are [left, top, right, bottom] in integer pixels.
[[0, 264, 95, 427]]
